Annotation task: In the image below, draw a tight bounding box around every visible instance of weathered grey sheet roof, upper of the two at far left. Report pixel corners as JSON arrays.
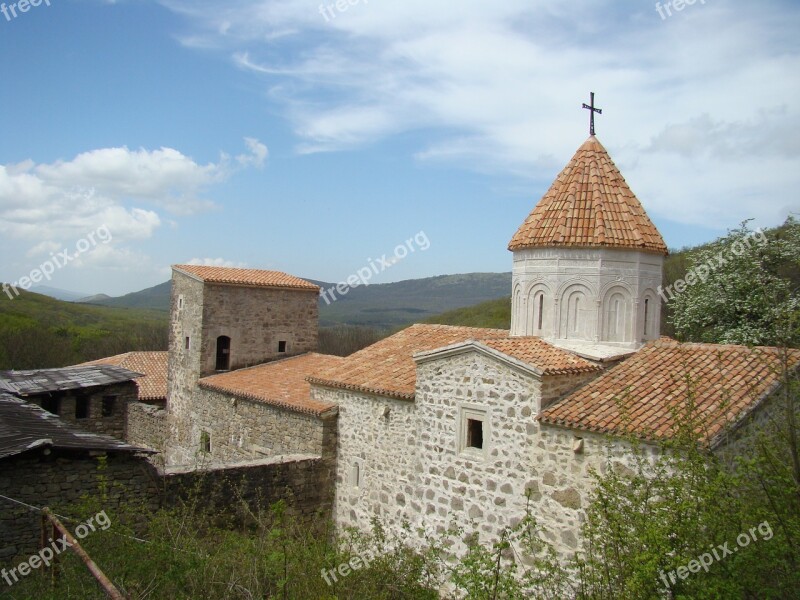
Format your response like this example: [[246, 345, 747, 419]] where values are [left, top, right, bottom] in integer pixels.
[[0, 365, 142, 396]]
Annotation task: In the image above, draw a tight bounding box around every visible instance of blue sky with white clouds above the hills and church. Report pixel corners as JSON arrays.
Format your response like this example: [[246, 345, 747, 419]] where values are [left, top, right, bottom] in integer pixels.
[[0, 0, 800, 295]]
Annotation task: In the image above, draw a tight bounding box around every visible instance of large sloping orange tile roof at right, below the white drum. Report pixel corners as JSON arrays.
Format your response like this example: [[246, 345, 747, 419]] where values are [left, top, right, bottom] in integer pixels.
[[539, 338, 800, 444]]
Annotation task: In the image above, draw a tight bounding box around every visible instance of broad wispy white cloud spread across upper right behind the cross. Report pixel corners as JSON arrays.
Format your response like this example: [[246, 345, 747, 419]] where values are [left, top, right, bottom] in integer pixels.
[[156, 0, 800, 227]]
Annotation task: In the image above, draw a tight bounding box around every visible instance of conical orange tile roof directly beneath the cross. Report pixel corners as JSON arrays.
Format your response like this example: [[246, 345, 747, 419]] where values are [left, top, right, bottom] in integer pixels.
[[508, 137, 667, 254]]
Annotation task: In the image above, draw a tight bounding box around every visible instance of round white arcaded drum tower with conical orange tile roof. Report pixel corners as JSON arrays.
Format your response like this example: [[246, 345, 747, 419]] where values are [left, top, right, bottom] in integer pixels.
[[508, 136, 667, 349]]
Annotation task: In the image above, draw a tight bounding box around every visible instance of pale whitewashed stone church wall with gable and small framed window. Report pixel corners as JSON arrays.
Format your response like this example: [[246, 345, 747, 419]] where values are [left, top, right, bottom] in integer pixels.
[[322, 350, 648, 556]]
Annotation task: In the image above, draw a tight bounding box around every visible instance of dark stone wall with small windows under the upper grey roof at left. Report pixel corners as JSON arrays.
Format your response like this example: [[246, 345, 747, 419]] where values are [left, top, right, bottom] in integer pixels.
[[27, 381, 138, 440]]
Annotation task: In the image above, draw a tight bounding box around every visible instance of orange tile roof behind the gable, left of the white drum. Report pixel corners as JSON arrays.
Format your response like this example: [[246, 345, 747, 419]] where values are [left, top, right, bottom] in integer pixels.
[[309, 325, 508, 400]]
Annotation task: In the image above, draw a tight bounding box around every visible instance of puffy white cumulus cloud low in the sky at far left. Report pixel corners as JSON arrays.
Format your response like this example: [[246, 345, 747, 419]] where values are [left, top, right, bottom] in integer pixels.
[[0, 138, 268, 264]]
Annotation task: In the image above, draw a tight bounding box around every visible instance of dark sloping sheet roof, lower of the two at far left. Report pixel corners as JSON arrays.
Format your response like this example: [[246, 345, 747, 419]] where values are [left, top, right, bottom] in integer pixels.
[[0, 393, 153, 459]]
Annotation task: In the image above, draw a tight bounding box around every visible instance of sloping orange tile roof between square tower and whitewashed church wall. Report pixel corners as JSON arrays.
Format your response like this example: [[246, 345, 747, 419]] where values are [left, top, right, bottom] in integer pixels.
[[199, 353, 344, 415]]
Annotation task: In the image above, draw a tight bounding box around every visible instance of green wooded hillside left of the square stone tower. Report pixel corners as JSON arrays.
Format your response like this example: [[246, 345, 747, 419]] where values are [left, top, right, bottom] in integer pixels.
[[0, 292, 168, 369]]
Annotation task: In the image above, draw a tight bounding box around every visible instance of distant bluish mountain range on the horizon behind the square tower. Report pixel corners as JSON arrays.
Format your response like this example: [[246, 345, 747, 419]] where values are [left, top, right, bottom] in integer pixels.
[[72, 273, 511, 329]]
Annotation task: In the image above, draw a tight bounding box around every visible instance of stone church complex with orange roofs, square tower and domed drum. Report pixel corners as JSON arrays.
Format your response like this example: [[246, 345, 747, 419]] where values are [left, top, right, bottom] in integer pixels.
[[136, 136, 800, 554]]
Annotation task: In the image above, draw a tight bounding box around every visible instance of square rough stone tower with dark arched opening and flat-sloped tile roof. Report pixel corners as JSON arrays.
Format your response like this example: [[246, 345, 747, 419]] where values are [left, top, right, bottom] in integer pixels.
[[167, 265, 319, 463]]
